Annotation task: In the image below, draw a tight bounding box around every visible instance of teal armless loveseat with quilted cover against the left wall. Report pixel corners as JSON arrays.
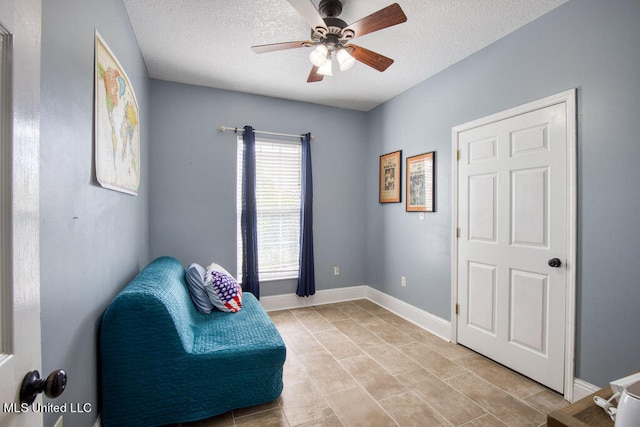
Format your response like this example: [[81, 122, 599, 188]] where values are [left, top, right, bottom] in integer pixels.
[[100, 257, 286, 427]]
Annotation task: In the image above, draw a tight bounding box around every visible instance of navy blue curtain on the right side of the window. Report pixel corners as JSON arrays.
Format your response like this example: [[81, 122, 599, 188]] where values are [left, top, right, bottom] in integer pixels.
[[296, 133, 316, 297]]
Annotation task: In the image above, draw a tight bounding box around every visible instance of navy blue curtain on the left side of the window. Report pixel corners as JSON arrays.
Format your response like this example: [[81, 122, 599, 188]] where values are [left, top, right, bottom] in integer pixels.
[[240, 126, 260, 299]]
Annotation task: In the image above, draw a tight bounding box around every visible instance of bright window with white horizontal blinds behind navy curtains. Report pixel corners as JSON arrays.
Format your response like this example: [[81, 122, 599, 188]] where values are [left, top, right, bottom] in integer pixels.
[[237, 135, 302, 281]]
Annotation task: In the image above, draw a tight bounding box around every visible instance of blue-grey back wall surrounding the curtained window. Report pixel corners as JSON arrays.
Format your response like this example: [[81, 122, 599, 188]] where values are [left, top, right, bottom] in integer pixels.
[[149, 80, 367, 296]]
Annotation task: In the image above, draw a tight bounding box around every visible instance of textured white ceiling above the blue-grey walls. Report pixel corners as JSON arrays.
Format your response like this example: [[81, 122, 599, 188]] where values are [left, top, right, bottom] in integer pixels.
[[124, 0, 567, 111]]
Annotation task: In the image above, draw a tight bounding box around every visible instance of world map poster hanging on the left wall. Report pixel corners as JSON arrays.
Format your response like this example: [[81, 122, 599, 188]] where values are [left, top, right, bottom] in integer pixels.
[[94, 31, 140, 195]]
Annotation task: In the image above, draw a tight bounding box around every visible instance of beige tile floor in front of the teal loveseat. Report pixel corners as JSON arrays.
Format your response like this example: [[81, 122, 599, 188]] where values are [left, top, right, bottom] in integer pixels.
[[178, 300, 568, 427]]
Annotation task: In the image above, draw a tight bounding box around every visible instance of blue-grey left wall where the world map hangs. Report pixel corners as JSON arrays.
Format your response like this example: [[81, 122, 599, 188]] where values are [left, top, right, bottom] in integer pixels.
[[40, 0, 151, 426]]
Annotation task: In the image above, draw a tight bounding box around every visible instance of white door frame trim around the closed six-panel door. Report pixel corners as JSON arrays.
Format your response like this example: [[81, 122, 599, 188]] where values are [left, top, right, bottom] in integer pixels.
[[451, 88, 577, 402]]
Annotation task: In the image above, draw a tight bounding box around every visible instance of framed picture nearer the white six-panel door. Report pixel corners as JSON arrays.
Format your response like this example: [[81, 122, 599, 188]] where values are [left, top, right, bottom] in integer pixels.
[[407, 151, 436, 212]]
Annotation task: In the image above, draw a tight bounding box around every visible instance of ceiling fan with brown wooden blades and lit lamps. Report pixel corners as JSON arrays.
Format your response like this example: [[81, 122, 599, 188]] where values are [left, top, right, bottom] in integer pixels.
[[251, 0, 407, 83]]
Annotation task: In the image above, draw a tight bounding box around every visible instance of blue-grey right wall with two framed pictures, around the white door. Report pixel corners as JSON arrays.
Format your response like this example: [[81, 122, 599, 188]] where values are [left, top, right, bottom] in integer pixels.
[[366, 0, 640, 386]]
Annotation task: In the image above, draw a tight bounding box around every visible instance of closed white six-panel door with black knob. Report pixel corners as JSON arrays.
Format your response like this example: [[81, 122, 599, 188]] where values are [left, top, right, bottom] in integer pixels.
[[454, 91, 574, 398]]
